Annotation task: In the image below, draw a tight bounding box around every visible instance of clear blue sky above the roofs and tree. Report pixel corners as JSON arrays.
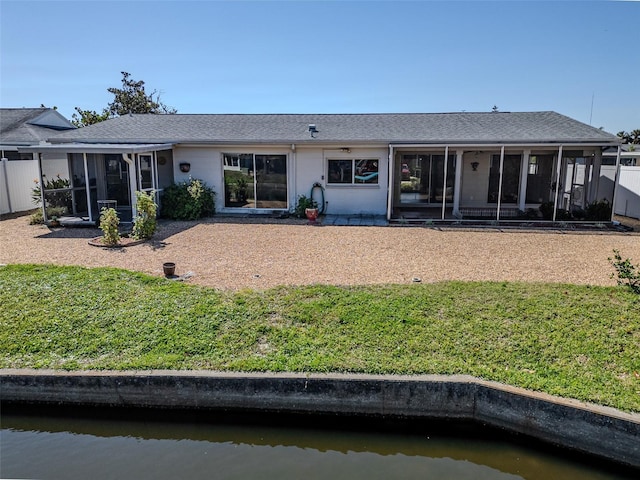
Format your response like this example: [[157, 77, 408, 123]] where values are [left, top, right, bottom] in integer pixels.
[[0, 0, 640, 133]]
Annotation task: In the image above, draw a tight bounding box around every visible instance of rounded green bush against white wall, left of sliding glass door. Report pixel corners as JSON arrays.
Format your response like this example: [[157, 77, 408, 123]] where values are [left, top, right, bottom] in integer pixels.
[[161, 178, 216, 220]]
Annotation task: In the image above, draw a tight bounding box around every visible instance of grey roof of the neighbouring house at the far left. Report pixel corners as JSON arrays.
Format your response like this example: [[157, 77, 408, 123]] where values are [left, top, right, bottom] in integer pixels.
[[0, 107, 76, 145]]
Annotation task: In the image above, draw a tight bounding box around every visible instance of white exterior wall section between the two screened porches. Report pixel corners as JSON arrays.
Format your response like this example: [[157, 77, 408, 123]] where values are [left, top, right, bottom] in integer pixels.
[[173, 145, 388, 215]]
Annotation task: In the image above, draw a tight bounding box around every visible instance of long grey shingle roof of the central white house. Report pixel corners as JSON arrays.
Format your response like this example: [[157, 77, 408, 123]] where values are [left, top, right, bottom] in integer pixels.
[[50, 112, 619, 144]]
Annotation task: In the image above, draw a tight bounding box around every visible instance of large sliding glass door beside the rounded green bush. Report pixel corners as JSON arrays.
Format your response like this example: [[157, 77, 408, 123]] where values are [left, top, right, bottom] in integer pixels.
[[222, 153, 288, 209]]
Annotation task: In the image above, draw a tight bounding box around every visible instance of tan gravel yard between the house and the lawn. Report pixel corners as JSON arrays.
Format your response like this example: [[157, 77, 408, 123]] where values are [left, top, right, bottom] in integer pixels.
[[0, 216, 640, 290]]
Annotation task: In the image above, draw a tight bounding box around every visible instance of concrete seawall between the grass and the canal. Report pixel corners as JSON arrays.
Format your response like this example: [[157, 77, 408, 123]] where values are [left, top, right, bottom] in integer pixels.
[[0, 370, 640, 468]]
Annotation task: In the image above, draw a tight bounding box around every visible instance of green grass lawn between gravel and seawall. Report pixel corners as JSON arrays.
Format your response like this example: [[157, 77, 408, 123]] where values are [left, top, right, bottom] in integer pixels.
[[0, 265, 640, 411]]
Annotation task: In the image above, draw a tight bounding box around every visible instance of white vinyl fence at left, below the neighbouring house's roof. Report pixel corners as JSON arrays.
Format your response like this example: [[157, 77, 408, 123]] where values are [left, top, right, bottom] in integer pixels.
[[0, 158, 38, 215]]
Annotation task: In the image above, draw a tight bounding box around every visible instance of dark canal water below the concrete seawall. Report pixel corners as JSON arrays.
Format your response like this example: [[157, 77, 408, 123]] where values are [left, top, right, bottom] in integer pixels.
[[0, 406, 637, 480]]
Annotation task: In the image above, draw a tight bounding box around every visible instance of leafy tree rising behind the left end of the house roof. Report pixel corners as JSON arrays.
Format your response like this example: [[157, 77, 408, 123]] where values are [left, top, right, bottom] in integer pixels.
[[71, 72, 177, 127]]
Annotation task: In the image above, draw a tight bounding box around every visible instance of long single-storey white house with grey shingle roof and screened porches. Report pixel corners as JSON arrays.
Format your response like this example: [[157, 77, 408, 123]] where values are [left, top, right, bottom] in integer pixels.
[[21, 112, 620, 221]]
